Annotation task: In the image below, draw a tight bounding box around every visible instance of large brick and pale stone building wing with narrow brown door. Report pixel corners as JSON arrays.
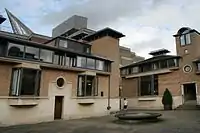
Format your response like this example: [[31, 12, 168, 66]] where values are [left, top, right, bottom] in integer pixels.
[[0, 9, 124, 125]]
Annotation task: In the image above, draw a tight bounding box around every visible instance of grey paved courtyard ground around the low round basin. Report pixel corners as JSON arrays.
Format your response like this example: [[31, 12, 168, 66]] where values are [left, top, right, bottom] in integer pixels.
[[0, 110, 200, 133]]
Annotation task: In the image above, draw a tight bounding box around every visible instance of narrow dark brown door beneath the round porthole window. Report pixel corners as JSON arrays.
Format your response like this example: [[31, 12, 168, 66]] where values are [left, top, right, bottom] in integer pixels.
[[54, 96, 63, 119]]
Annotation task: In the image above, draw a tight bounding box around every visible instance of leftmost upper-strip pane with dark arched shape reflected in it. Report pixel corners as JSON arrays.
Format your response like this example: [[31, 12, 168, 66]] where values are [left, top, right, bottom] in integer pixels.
[[8, 43, 24, 58]]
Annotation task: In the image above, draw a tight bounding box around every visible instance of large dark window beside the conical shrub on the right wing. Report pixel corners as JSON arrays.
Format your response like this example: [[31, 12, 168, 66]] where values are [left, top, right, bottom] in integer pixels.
[[139, 75, 158, 96]]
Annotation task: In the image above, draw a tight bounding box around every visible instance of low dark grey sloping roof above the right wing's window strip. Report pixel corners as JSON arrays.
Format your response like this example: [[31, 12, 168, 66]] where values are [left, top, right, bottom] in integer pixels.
[[121, 55, 180, 68]]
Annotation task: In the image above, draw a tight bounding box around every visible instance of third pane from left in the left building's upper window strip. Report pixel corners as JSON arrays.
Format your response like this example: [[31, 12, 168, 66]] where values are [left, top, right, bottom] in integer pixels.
[[40, 49, 53, 63]]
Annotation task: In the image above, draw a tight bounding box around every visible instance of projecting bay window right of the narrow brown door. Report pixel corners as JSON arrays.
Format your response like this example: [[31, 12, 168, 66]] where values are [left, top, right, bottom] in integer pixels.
[[77, 75, 98, 97]]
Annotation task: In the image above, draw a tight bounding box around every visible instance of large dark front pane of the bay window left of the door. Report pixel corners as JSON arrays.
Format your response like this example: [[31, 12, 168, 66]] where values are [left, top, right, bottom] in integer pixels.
[[20, 69, 38, 95]]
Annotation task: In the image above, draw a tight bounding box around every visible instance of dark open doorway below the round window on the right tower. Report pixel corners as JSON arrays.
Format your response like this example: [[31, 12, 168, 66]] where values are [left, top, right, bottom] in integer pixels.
[[183, 83, 197, 103]]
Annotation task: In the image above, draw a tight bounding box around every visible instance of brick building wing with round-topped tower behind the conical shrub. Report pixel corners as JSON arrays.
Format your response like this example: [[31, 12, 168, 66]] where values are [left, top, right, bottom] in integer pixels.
[[121, 27, 200, 109]]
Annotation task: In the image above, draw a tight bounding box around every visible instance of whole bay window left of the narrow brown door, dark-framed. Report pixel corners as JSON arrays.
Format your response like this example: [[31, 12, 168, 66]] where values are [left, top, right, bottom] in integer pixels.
[[10, 68, 41, 96]]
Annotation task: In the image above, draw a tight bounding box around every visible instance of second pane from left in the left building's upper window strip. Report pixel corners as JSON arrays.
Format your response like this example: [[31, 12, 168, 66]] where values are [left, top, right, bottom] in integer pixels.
[[25, 46, 39, 60]]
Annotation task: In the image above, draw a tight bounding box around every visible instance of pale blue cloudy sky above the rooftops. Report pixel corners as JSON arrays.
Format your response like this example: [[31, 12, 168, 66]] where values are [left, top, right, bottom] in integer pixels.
[[0, 0, 200, 57]]
